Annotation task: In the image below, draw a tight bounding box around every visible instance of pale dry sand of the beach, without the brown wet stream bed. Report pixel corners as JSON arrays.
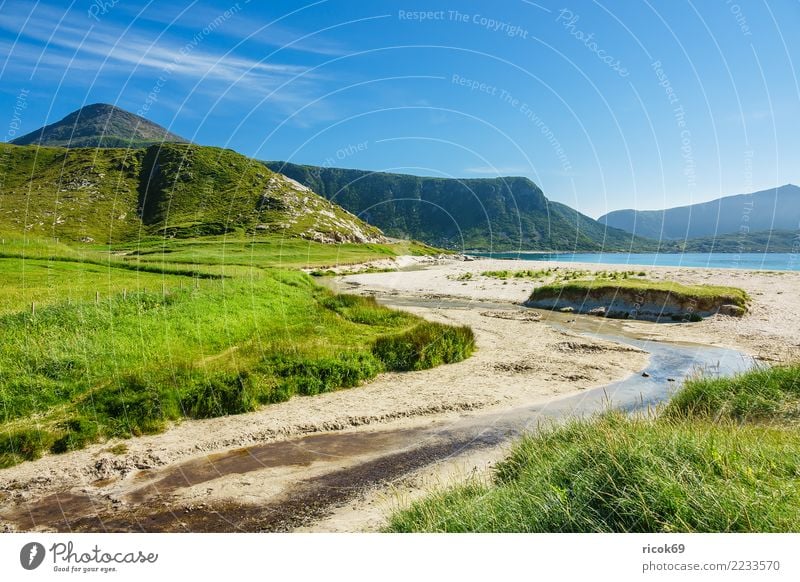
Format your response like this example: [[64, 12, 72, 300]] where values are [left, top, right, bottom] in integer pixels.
[[0, 259, 800, 531]]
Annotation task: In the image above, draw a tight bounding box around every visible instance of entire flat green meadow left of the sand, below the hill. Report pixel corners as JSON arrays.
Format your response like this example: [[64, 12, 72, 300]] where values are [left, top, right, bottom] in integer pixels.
[[0, 239, 474, 467]]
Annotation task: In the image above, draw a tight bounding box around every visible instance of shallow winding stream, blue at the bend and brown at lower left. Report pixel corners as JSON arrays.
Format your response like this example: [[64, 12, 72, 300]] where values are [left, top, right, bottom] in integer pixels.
[[3, 297, 753, 532]]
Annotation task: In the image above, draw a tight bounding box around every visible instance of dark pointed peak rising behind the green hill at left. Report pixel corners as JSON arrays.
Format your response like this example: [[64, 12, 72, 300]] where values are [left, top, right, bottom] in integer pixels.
[[11, 103, 188, 148]]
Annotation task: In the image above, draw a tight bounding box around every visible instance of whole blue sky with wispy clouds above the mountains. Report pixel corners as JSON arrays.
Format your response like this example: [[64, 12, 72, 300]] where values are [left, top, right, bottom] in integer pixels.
[[0, 0, 800, 217]]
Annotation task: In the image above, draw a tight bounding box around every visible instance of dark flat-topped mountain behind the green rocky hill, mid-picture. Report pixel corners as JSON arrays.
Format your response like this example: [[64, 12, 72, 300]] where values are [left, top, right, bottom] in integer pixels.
[[265, 162, 657, 251]]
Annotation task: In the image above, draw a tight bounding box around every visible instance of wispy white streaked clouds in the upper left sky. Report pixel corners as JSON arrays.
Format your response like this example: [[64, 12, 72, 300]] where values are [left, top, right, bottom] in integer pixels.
[[0, 4, 334, 118]]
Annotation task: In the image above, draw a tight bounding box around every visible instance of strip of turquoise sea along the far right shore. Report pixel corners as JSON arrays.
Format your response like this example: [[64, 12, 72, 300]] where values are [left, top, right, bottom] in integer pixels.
[[475, 252, 800, 271]]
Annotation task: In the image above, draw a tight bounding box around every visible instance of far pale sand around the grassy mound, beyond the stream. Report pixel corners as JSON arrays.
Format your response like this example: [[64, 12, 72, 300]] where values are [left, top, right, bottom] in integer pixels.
[[336, 259, 800, 362]]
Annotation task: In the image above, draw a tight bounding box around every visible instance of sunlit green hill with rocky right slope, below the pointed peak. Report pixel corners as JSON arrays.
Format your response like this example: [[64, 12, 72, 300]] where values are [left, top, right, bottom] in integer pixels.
[[0, 144, 384, 242]]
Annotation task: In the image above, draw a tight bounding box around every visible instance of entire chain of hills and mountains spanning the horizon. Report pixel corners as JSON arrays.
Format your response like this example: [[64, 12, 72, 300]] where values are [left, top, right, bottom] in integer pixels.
[[0, 103, 800, 252]]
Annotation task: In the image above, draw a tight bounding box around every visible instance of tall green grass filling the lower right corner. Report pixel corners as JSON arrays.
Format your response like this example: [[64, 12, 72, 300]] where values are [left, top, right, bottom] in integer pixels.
[[388, 365, 800, 532]]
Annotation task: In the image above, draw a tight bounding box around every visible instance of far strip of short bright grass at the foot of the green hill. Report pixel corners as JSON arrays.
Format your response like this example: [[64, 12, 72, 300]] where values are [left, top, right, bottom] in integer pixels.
[[0, 236, 440, 314]]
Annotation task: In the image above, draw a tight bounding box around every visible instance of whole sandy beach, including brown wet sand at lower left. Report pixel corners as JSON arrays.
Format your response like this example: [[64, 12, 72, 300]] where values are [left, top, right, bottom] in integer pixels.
[[0, 260, 800, 531]]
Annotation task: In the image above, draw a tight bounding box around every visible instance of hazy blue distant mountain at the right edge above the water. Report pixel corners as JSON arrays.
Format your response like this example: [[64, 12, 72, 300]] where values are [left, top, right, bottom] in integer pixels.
[[599, 184, 800, 239]]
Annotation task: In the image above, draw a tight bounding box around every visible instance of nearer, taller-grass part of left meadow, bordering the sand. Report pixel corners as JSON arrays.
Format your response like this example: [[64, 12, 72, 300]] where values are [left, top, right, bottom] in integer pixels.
[[0, 262, 473, 466]]
